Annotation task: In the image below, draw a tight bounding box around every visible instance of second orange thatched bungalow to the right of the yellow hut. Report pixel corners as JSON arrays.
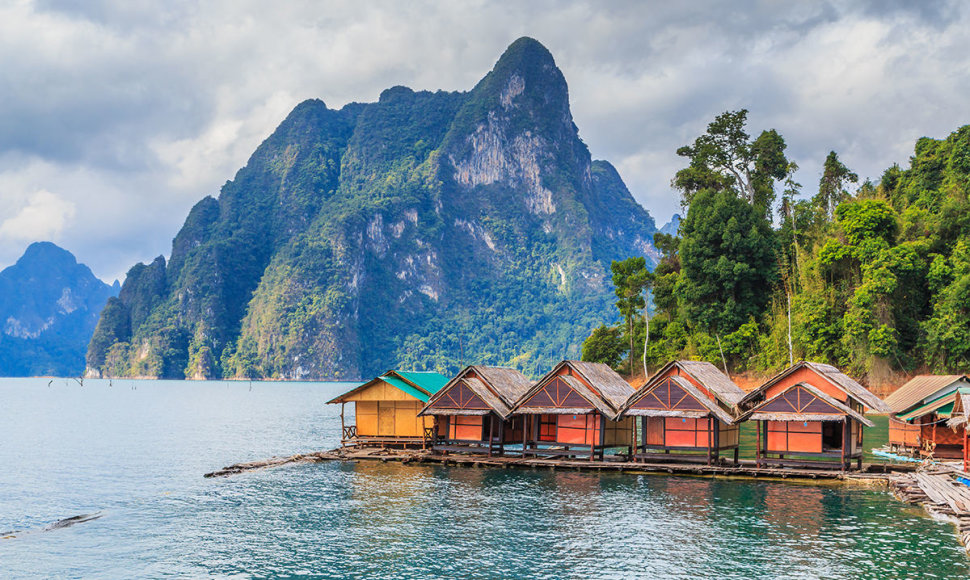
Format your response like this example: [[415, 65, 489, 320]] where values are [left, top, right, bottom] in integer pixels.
[[512, 360, 633, 460]]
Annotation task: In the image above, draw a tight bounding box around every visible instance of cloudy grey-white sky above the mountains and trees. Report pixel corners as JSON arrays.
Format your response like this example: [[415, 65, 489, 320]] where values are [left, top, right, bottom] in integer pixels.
[[0, 0, 970, 282]]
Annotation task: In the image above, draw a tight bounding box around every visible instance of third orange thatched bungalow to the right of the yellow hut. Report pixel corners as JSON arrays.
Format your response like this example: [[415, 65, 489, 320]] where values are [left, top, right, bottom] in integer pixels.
[[619, 360, 744, 465]]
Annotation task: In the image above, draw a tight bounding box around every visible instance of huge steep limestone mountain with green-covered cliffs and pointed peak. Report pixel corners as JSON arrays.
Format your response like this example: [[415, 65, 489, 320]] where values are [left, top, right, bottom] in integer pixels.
[[88, 38, 656, 379]]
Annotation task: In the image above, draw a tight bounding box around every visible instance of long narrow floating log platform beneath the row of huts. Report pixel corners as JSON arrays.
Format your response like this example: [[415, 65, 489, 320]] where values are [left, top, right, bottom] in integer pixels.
[[205, 448, 913, 481]]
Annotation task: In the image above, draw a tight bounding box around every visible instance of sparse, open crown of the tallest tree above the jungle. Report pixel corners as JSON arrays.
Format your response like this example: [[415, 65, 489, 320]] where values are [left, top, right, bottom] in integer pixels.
[[671, 109, 788, 214]]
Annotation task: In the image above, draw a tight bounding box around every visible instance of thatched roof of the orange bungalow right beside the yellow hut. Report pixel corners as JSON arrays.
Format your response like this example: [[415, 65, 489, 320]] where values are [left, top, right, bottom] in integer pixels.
[[418, 365, 532, 419]]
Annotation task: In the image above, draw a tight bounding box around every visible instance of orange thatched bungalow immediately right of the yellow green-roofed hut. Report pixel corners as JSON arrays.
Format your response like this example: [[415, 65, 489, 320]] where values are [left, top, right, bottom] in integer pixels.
[[418, 366, 532, 456]]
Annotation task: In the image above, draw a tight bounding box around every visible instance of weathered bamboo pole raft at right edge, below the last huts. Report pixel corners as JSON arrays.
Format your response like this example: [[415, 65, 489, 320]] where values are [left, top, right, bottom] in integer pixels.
[[889, 467, 970, 551]]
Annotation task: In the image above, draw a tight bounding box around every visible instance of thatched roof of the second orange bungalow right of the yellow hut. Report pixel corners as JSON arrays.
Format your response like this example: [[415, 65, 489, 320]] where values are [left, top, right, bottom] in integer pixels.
[[512, 360, 633, 420]]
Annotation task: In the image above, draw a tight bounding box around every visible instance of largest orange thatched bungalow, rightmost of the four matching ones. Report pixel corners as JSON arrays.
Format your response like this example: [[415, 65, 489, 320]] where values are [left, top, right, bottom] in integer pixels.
[[739, 361, 889, 469]]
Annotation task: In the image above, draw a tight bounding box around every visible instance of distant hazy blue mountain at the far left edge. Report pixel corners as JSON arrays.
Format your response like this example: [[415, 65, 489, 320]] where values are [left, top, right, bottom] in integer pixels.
[[0, 242, 119, 377]]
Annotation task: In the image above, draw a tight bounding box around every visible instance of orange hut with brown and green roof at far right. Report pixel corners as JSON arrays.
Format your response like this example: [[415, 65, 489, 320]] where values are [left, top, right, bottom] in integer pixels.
[[886, 375, 970, 459]]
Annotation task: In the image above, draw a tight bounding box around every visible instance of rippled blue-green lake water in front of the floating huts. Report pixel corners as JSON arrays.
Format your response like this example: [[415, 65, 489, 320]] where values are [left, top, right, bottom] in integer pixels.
[[0, 379, 970, 578]]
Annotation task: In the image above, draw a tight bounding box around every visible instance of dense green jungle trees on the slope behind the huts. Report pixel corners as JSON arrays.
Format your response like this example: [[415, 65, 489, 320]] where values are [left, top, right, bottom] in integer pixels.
[[583, 115, 970, 384]]
